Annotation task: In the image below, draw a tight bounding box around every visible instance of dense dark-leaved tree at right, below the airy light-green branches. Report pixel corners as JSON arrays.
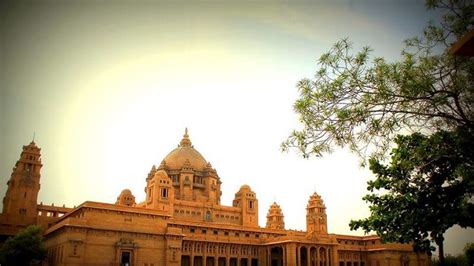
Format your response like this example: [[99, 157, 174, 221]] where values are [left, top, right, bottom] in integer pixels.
[[350, 127, 474, 265]]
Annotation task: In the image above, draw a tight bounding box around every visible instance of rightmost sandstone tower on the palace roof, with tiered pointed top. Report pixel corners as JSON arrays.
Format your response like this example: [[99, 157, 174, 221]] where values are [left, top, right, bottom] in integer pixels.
[[306, 192, 328, 235]]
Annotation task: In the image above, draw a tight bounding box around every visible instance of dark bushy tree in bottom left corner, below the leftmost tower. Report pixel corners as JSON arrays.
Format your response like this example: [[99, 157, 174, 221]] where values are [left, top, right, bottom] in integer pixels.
[[0, 225, 46, 266]]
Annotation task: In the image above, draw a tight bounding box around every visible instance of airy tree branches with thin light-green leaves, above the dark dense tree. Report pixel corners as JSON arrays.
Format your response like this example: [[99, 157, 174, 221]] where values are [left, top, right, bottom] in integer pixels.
[[282, 0, 474, 162]]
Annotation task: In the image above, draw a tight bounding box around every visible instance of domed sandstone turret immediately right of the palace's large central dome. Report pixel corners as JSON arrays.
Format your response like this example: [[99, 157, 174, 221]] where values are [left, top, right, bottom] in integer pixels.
[[232, 185, 258, 226]]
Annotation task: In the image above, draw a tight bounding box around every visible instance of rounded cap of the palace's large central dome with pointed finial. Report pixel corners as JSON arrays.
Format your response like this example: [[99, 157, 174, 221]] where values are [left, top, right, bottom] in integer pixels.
[[163, 129, 207, 171]]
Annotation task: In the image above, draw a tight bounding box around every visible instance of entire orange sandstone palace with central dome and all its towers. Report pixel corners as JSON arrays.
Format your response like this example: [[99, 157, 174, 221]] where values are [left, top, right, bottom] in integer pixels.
[[0, 130, 429, 266]]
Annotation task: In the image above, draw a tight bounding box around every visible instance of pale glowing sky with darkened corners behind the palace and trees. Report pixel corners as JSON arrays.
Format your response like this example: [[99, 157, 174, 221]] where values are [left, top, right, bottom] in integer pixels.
[[0, 0, 474, 254]]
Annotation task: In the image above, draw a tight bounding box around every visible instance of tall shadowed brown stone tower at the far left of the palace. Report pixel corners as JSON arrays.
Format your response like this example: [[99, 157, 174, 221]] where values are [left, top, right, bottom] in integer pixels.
[[3, 141, 43, 225]]
